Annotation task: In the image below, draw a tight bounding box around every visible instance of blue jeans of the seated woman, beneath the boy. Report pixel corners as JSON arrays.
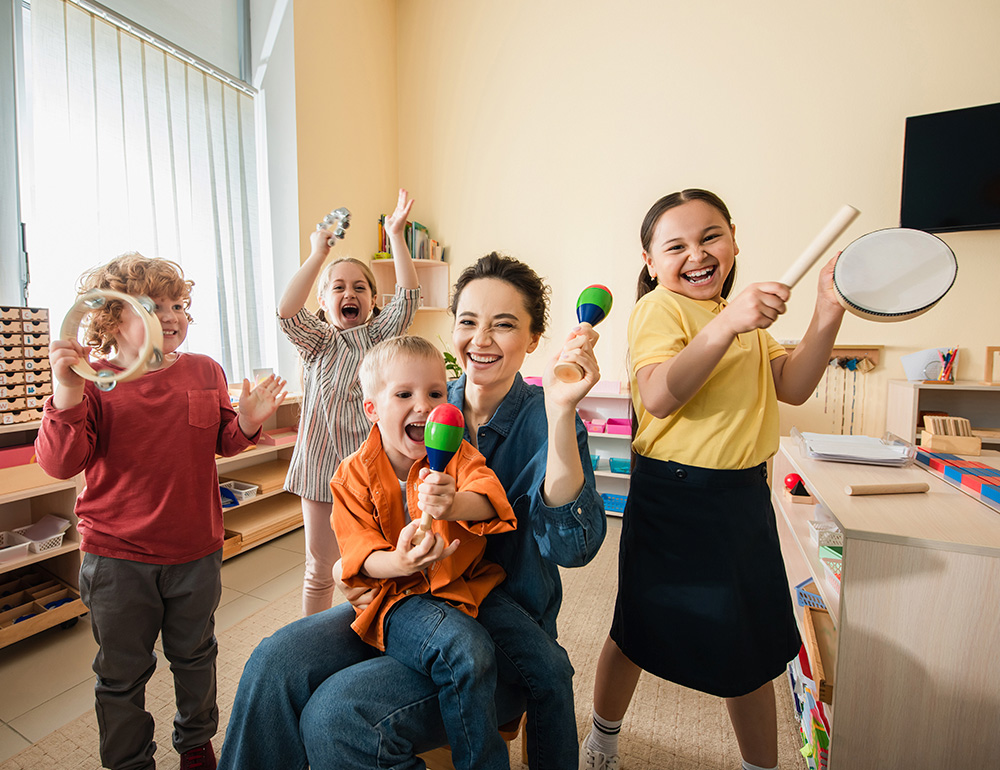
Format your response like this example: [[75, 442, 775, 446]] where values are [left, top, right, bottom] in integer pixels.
[[219, 589, 579, 770]]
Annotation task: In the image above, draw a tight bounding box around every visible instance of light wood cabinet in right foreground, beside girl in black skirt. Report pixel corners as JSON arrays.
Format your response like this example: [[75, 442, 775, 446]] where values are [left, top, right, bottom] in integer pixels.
[[773, 436, 1000, 770]]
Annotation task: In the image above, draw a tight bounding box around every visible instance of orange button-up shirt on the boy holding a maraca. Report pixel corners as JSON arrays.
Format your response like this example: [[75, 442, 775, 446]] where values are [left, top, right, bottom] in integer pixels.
[[330, 426, 517, 650]]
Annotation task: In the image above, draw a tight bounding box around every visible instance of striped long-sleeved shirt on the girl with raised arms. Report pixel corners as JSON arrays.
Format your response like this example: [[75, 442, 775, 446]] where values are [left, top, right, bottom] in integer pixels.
[[278, 286, 420, 503]]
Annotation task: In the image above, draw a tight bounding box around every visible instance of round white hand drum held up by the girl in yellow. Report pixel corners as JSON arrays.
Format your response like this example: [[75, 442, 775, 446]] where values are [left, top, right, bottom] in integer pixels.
[[833, 227, 958, 321]]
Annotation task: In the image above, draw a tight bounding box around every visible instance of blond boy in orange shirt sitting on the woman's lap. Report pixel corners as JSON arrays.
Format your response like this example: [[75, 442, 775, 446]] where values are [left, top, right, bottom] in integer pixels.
[[330, 337, 516, 770]]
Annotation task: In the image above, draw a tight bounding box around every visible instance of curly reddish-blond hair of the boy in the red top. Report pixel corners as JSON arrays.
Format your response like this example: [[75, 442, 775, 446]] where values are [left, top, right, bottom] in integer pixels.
[[77, 251, 194, 355]]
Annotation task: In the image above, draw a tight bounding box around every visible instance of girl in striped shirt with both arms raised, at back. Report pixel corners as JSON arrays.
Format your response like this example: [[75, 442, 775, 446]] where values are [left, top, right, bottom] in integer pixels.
[[278, 190, 420, 615]]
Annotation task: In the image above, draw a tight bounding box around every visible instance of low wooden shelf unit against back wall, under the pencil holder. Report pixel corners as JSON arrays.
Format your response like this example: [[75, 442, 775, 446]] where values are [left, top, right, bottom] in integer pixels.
[[885, 380, 1000, 449]]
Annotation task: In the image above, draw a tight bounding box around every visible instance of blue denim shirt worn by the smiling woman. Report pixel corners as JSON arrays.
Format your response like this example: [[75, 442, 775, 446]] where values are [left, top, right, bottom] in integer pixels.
[[448, 374, 607, 638]]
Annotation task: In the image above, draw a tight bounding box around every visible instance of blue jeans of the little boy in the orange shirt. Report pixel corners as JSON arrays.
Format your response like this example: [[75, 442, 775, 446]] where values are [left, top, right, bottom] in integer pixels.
[[385, 594, 510, 770]]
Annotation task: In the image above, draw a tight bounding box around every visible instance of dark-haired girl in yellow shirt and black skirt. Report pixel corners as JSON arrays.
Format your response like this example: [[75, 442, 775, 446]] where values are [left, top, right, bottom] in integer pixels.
[[580, 189, 844, 770]]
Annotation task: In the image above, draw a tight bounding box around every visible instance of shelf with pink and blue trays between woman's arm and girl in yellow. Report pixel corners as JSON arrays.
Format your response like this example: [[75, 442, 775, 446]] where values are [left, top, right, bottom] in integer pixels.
[[577, 390, 632, 516]]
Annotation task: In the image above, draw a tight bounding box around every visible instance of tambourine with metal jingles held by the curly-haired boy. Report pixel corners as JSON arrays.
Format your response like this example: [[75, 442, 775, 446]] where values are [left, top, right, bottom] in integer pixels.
[[59, 289, 163, 390]]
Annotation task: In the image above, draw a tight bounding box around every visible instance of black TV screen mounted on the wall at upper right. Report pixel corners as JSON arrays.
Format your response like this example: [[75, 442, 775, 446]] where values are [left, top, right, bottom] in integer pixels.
[[899, 104, 1000, 232]]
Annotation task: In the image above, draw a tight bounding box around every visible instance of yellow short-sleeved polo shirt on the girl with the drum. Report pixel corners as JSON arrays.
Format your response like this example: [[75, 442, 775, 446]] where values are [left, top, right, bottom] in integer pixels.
[[628, 286, 787, 470]]
